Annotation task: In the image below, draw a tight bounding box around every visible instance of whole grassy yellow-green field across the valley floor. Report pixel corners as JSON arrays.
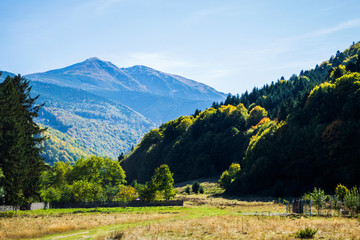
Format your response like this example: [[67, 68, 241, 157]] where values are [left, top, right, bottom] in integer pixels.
[[0, 182, 360, 240]]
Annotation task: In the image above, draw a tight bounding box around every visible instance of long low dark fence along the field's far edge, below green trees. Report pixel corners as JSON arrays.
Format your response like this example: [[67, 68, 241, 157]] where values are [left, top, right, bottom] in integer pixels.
[[0, 200, 184, 212]]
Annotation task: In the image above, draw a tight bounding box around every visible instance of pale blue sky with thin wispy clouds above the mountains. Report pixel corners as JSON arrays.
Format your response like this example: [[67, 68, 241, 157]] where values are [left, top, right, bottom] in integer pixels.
[[0, 0, 360, 94]]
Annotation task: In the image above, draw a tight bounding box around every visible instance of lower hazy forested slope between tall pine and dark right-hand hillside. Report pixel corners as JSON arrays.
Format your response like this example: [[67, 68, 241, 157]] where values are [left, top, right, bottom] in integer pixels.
[[31, 81, 154, 163]]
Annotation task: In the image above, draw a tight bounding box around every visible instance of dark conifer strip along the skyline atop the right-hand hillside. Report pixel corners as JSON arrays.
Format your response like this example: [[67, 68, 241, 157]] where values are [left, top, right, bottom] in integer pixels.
[[213, 43, 359, 120]]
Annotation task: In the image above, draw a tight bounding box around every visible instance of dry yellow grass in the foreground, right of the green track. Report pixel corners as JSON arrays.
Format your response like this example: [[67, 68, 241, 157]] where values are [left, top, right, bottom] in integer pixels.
[[112, 216, 360, 240]]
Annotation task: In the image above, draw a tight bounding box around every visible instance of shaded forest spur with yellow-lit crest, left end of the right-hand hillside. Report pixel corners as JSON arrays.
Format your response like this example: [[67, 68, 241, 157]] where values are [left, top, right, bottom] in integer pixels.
[[122, 104, 258, 182]]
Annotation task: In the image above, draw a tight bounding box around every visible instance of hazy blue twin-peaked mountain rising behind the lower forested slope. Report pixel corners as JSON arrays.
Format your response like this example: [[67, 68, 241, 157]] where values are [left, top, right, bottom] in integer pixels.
[[25, 58, 225, 123]]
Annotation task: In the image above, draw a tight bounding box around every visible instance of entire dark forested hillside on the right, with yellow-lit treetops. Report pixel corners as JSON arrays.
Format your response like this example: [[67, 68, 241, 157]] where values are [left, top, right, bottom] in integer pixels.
[[122, 43, 360, 196]]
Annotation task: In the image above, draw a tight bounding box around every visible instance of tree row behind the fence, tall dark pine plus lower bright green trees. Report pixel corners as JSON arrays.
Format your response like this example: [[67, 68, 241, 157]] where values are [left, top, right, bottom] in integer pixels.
[[0, 72, 175, 205]]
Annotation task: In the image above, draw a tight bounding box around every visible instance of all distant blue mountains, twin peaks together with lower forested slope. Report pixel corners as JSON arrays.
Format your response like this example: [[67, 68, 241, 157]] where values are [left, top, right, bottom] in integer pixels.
[[0, 58, 225, 163]]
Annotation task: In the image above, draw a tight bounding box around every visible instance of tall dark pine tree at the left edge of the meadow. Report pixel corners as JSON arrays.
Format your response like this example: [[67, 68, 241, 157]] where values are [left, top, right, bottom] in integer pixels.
[[0, 75, 45, 205]]
